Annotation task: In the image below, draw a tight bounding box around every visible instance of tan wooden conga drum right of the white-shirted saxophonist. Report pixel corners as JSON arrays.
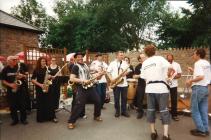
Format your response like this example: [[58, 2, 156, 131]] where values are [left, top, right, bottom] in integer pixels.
[[127, 79, 138, 104]]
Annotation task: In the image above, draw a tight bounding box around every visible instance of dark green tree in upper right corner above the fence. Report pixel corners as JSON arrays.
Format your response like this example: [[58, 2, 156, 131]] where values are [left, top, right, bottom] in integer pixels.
[[157, 0, 211, 48]]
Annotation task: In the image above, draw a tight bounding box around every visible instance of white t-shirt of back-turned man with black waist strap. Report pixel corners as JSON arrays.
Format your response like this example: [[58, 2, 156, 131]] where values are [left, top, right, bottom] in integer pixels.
[[140, 56, 171, 93]]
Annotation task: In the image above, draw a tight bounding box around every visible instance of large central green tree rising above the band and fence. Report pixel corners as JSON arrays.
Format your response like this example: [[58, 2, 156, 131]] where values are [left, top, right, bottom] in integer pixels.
[[48, 0, 165, 52]]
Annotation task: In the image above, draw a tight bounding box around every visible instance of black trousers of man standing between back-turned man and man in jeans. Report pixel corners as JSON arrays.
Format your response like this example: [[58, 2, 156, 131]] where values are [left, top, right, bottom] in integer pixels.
[[170, 87, 177, 117]]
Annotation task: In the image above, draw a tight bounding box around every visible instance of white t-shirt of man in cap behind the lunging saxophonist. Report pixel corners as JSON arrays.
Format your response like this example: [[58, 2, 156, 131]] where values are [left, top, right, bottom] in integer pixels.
[[90, 60, 108, 83]]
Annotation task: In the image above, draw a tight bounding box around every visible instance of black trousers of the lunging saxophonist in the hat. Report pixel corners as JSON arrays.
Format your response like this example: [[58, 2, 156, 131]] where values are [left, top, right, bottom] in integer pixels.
[[68, 86, 101, 123]]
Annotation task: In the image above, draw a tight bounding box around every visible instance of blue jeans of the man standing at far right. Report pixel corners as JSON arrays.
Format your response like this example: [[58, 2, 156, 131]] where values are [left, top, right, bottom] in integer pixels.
[[191, 85, 209, 132]]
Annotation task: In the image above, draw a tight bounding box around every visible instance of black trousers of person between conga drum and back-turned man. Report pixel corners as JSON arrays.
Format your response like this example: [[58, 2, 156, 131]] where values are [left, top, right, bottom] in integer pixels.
[[136, 84, 145, 113]]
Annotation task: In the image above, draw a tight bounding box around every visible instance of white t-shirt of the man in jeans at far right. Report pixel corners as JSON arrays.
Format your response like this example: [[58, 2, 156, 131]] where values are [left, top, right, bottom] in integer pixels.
[[192, 59, 211, 86]]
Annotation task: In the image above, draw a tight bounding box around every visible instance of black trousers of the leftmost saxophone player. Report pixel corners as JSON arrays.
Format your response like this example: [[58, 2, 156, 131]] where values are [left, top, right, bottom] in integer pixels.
[[7, 86, 27, 122]]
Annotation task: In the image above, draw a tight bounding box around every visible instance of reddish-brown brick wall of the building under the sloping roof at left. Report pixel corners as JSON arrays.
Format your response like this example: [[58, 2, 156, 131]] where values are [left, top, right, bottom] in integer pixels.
[[0, 27, 38, 56]]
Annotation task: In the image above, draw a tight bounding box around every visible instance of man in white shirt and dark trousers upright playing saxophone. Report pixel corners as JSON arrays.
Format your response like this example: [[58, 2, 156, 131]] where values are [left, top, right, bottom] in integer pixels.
[[107, 51, 130, 117]]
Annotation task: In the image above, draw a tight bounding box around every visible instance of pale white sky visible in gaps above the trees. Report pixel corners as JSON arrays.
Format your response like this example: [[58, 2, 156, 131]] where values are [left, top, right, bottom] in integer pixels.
[[0, 0, 191, 16]]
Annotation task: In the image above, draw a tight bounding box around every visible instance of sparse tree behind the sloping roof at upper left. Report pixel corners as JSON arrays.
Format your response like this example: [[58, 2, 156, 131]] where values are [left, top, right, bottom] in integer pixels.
[[11, 0, 55, 47]]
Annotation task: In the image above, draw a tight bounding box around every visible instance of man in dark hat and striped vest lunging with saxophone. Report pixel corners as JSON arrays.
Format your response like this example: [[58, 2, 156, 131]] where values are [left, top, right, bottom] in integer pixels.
[[68, 52, 102, 129]]
